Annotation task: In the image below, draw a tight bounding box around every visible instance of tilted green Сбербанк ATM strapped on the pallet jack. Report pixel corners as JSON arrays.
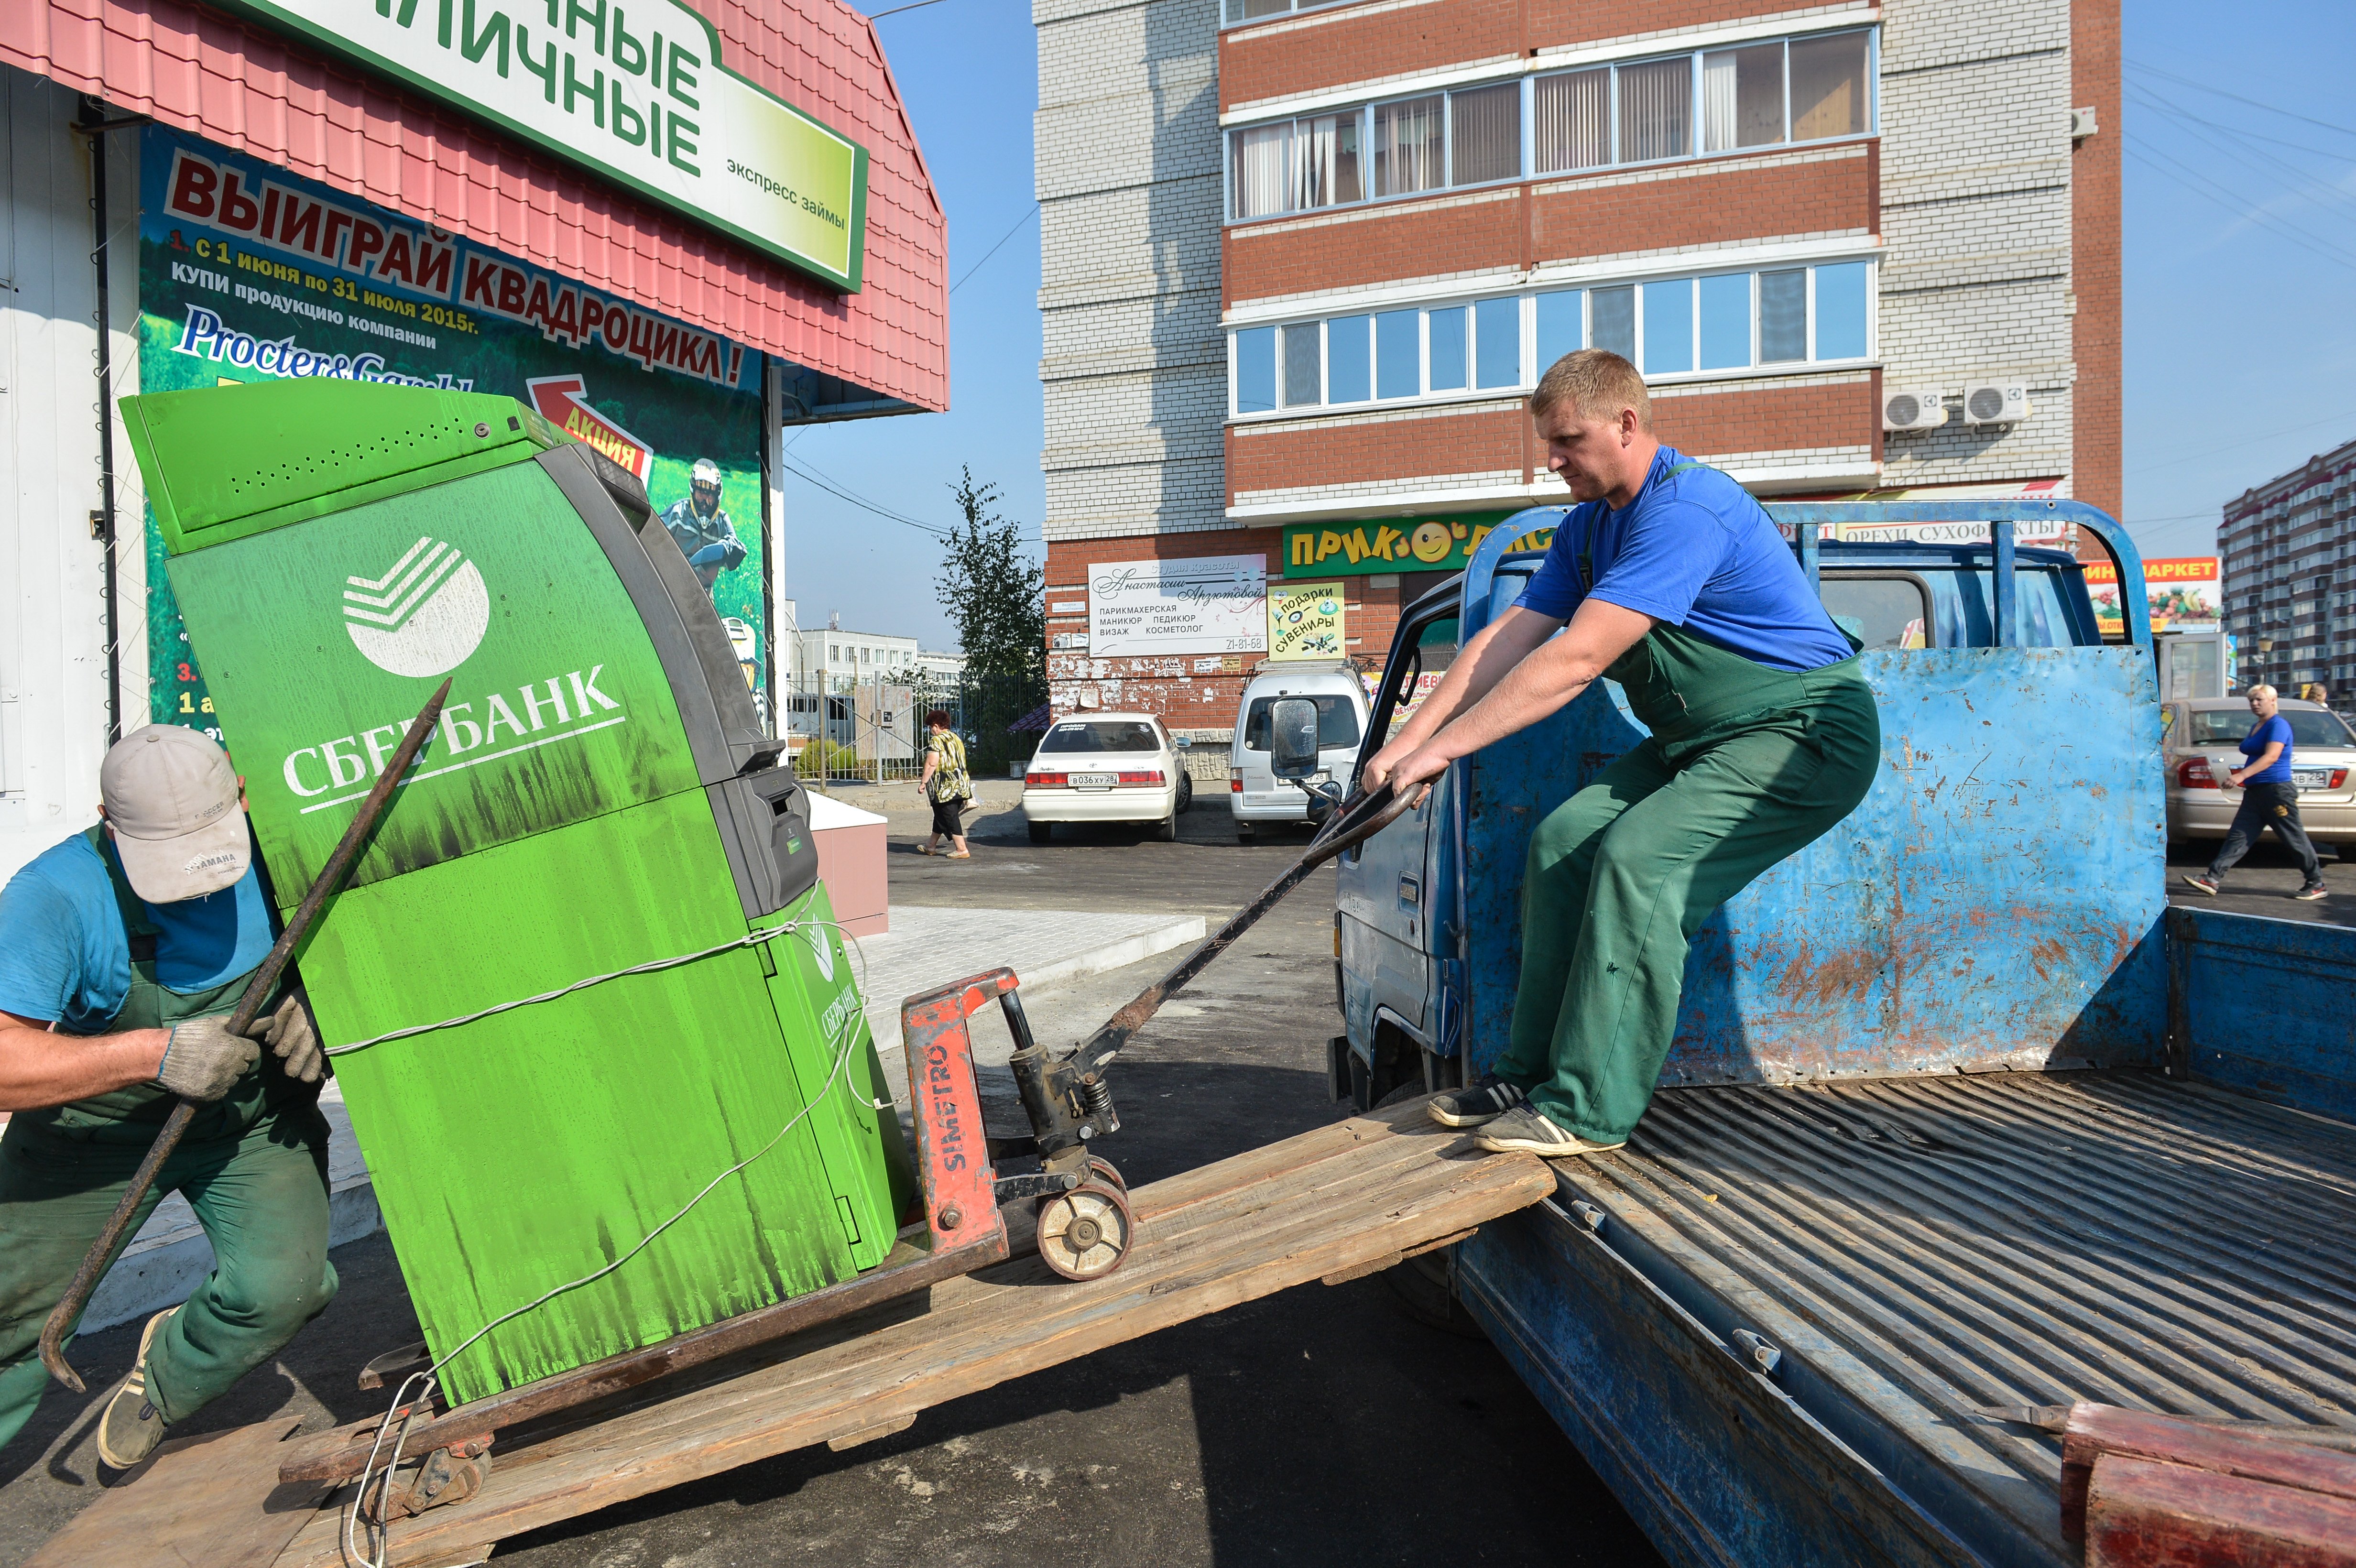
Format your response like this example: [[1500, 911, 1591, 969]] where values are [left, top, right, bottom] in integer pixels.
[[122, 379, 912, 1403]]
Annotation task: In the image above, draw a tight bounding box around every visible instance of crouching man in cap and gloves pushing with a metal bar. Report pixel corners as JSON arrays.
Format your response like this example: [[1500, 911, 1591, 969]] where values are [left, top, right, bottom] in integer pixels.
[[0, 725, 335, 1469]]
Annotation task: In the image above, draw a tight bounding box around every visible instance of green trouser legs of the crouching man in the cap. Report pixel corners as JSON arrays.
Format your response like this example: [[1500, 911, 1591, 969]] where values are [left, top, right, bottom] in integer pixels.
[[0, 1097, 335, 1446]]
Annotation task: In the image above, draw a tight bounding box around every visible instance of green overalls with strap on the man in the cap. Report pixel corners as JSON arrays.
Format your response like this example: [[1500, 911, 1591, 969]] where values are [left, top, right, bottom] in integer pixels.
[[0, 827, 335, 1446]]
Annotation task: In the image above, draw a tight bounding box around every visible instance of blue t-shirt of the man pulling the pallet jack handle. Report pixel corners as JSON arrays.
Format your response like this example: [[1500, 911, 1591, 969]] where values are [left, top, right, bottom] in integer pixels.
[[1513, 447, 1854, 671]]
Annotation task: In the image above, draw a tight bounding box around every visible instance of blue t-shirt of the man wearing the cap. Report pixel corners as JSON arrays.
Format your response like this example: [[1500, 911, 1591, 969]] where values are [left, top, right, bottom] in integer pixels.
[[0, 833, 276, 1034]]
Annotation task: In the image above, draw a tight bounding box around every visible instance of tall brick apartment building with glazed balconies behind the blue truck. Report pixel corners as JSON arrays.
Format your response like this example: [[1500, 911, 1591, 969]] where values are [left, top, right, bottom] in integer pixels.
[[1034, 0, 2120, 732]]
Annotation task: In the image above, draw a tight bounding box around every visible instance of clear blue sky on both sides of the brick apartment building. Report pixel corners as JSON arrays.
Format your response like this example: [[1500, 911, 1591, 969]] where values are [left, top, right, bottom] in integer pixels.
[[782, 0, 2356, 645]]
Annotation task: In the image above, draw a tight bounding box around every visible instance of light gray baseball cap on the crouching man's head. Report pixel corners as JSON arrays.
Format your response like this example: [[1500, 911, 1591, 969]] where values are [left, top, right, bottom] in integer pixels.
[[99, 725, 252, 904]]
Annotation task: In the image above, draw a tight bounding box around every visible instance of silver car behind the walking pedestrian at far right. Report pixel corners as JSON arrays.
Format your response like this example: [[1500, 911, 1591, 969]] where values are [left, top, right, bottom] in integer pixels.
[[2160, 697, 2356, 860]]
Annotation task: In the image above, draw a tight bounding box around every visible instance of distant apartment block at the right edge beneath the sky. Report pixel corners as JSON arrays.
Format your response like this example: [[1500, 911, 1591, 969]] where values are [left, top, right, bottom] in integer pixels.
[[2217, 440, 2356, 706]]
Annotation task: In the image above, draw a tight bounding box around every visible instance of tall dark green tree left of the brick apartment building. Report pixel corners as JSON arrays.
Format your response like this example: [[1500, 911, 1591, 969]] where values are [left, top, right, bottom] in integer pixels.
[[933, 468, 1046, 772]]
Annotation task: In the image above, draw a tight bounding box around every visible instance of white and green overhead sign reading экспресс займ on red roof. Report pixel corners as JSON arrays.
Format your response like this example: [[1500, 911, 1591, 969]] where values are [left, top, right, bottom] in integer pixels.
[[207, 0, 867, 292]]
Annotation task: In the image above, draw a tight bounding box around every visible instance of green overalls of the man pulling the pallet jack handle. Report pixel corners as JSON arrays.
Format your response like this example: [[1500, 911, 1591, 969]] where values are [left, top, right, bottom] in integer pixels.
[[1496, 461, 1880, 1144]]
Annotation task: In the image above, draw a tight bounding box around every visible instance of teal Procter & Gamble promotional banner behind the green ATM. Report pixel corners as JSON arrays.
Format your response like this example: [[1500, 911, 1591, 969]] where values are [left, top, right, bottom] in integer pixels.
[[139, 125, 768, 739]]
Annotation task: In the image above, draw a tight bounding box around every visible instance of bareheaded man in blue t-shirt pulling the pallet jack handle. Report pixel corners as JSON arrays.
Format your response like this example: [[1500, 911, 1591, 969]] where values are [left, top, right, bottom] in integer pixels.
[[1366, 348, 1880, 1158]]
